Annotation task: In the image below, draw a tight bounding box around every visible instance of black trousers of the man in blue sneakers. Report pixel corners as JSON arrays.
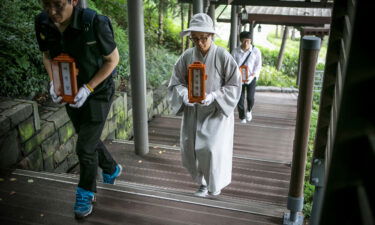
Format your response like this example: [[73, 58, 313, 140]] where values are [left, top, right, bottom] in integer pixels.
[[66, 96, 117, 192]]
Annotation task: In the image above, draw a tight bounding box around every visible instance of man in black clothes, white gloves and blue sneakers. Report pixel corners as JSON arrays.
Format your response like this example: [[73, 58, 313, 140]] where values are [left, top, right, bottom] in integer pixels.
[[35, 0, 122, 218]]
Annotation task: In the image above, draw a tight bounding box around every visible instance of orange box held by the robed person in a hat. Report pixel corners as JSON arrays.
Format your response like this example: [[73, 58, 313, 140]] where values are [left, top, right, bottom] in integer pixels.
[[188, 62, 207, 103]]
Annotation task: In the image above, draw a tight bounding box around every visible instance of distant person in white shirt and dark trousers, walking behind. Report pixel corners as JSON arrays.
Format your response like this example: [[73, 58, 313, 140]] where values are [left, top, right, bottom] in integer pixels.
[[232, 31, 262, 123]]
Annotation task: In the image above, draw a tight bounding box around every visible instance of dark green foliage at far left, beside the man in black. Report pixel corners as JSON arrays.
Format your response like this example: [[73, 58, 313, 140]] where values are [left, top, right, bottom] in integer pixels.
[[0, 0, 48, 99]]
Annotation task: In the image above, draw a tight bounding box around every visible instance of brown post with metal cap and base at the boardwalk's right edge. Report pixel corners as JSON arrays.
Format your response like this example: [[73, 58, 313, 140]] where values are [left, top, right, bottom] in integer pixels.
[[284, 36, 321, 225]]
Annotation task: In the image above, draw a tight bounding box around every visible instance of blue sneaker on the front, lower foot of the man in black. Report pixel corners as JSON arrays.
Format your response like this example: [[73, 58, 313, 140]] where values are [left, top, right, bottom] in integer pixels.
[[74, 187, 95, 219]]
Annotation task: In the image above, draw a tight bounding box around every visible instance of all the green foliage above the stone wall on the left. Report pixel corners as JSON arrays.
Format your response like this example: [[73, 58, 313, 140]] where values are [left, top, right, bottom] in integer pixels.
[[0, 0, 179, 99]]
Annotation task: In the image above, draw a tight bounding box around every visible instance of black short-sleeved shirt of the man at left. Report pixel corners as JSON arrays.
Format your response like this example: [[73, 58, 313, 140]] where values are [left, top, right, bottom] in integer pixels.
[[35, 7, 116, 94]]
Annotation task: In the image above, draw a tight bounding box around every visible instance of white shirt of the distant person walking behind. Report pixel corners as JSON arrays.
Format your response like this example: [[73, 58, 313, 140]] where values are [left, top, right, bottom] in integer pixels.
[[232, 46, 262, 83]]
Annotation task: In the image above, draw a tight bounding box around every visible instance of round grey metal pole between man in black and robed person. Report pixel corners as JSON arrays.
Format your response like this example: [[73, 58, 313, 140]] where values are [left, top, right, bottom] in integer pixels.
[[128, 0, 149, 155]]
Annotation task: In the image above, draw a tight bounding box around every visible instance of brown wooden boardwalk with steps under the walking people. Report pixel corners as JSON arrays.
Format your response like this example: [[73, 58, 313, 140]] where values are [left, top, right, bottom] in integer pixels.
[[0, 92, 297, 225]]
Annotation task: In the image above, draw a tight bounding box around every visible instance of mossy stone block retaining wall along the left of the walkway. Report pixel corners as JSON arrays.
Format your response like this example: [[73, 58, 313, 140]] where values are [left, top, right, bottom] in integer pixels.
[[0, 91, 168, 172]]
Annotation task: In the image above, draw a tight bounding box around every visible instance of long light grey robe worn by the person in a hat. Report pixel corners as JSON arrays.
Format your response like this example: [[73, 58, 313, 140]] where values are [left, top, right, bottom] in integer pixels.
[[168, 43, 242, 192]]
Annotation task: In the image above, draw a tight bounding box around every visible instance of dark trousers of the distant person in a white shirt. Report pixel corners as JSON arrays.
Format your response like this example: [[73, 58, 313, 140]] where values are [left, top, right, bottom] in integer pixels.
[[237, 78, 256, 120]]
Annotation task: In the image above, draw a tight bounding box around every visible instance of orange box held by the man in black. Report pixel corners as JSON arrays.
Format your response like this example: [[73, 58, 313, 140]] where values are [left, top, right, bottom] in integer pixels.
[[51, 54, 78, 103]]
